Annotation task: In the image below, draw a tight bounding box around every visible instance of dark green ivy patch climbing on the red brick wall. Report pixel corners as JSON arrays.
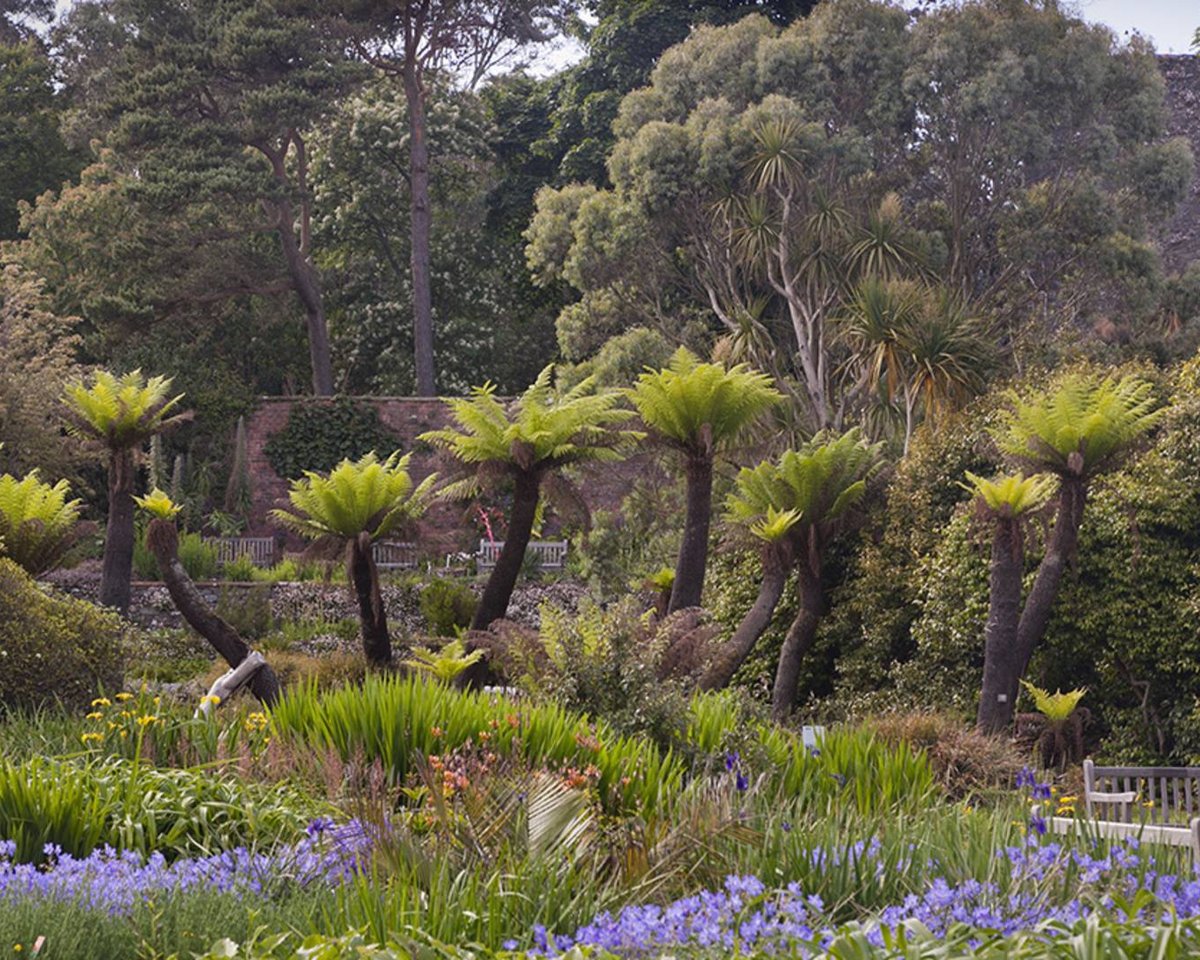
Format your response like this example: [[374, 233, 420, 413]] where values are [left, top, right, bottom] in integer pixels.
[[264, 397, 396, 480]]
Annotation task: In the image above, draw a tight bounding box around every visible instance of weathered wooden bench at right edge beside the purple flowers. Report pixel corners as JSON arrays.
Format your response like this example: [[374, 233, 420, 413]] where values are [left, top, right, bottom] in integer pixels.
[[1046, 760, 1200, 863]]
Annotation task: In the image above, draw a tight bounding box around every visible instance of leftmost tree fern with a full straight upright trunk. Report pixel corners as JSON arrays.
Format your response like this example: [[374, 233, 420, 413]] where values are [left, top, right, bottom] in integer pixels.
[[64, 370, 192, 613]]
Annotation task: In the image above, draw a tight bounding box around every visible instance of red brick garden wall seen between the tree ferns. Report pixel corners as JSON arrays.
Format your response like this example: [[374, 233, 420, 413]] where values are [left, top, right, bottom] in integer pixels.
[[246, 397, 647, 558]]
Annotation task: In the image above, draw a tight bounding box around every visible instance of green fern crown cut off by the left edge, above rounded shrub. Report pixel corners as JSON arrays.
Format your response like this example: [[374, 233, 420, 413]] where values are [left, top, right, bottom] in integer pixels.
[[0, 470, 79, 576]]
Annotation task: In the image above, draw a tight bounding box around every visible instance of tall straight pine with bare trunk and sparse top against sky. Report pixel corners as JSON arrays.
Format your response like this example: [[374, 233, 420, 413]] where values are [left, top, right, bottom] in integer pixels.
[[336, 0, 574, 396]]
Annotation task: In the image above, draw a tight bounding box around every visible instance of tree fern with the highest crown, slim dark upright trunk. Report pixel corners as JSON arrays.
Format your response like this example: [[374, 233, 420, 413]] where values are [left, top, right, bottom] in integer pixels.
[[629, 347, 782, 613]]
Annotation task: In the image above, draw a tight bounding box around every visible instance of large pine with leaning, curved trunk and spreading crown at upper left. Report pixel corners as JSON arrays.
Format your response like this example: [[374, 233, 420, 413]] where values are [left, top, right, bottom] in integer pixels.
[[64, 0, 360, 395]]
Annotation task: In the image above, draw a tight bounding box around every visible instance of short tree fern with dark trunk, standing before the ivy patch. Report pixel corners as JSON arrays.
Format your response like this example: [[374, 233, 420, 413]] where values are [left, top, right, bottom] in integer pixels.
[[271, 452, 437, 666]]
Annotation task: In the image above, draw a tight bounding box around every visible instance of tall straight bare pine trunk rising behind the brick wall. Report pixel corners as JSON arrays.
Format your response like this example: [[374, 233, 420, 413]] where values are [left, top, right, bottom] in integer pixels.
[[404, 56, 437, 397]]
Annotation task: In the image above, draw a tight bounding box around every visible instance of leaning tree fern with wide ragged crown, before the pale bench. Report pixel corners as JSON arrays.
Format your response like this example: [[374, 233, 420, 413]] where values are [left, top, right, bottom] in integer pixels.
[[420, 364, 642, 628]]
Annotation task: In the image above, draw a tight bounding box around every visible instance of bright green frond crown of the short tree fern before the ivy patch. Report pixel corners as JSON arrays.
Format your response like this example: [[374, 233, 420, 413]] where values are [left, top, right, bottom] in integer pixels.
[[271, 451, 436, 541]]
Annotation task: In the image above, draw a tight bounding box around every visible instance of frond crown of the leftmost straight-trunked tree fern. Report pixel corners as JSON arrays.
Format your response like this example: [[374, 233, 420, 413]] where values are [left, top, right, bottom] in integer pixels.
[[64, 370, 191, 451]]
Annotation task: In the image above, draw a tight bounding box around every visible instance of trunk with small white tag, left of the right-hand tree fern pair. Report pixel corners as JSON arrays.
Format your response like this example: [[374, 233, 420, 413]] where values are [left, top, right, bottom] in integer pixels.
[[976, 517, 1025, 733]]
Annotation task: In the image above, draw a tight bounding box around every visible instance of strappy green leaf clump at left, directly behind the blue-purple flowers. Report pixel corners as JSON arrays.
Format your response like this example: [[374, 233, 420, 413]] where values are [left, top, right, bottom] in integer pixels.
[[0, 757, 319, 863]]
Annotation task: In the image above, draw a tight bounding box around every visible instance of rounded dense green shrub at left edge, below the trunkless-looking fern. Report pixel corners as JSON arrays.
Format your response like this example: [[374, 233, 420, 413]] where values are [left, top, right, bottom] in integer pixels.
[[0, 558, 125, 707]]
